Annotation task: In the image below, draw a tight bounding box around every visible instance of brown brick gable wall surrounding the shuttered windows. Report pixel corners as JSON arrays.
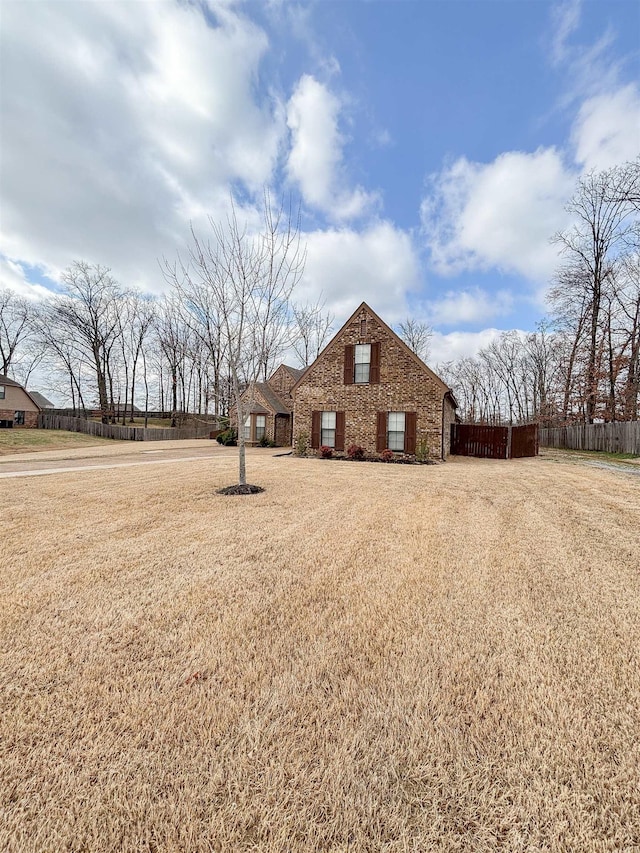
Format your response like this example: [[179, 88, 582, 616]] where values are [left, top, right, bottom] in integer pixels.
[[293, 310, 445, 459]]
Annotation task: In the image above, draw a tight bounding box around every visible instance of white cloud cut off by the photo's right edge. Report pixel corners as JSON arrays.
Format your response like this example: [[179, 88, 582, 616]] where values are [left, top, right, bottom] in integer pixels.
[[572, 84, 640, 169]]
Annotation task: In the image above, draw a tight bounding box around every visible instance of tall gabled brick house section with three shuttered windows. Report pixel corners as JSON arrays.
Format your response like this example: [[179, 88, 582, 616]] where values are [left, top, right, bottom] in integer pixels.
[[291, 302, 456, 459]]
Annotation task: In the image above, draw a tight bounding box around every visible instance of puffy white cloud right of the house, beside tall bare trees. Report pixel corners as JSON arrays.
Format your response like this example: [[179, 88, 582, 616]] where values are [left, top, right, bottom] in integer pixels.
[[421, 148, 574, 281]]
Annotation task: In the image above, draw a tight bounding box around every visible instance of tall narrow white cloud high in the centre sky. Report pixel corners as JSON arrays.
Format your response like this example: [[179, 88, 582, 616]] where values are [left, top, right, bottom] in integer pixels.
[[287, 74, 377, 221]]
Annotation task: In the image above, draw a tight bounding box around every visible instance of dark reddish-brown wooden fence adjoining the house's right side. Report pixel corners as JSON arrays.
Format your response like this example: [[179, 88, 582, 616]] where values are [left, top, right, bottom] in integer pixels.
[[451, 424, 538, 459]]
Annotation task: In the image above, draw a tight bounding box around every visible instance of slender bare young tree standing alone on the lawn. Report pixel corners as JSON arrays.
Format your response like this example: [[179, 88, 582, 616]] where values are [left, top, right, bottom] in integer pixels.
[[165, 193, 306, 491]]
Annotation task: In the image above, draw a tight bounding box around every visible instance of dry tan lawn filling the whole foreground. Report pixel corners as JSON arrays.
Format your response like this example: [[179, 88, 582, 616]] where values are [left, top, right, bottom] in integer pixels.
[[0, 452, 640, 853]]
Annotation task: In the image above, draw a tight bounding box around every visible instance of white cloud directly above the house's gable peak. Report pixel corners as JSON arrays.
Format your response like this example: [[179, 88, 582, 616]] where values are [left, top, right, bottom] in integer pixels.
[[299, 222, 419, 323]]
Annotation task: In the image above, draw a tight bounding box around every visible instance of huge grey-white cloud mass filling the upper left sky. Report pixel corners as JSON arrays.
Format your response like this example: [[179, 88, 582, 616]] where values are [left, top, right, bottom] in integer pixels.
[[0, 2, 286, 289]]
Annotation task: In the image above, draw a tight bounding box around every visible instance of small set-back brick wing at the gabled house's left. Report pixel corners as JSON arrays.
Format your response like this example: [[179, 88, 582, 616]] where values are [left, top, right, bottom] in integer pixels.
[[238, 364, 304, 447]]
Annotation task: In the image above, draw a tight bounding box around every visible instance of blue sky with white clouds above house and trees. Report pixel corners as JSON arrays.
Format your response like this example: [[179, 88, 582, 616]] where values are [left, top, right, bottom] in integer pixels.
[[0, 0, 640, 362]]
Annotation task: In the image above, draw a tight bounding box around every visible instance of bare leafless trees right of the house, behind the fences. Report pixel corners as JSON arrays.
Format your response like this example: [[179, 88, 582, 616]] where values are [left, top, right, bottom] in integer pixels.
[[439, 159, 640, 426]]
